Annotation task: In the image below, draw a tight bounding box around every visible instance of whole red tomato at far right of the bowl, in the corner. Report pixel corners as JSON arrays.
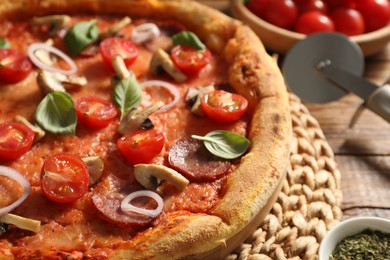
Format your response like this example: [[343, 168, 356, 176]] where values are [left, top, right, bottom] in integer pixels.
[[356, 0, 390, 32]]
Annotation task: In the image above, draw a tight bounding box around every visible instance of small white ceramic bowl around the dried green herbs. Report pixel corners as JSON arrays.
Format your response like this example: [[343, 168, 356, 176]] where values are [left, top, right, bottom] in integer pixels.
[[318, 217, 390, 260]]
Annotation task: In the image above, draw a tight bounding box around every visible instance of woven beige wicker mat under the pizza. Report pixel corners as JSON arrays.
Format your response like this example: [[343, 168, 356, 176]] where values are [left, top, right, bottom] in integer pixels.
[[226, 94, 342, 260]]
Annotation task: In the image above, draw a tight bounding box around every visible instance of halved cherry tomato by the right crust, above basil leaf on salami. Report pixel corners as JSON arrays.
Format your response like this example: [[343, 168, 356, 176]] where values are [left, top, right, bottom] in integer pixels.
[[201, 90, 248, 123]]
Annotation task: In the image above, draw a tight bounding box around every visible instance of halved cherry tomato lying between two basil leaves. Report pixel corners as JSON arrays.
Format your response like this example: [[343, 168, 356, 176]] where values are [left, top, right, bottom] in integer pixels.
[[75, 96, 117, 128]]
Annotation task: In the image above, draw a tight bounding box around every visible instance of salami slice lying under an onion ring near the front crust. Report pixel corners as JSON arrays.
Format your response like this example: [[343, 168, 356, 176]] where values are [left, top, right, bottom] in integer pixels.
[[92, 176, 156, 227]]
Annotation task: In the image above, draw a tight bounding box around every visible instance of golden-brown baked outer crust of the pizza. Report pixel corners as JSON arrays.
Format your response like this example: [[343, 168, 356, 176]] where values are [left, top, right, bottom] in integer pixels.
[[0, 0, 291, 259]]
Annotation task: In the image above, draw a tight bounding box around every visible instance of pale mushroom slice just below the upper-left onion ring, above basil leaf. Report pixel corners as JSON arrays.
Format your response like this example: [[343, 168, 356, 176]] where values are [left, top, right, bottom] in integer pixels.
[[37, 70, 87, 93]]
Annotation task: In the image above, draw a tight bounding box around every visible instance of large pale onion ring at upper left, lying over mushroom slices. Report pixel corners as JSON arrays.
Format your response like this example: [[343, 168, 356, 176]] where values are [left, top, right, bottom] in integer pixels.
[[27, 43, 77, 75]]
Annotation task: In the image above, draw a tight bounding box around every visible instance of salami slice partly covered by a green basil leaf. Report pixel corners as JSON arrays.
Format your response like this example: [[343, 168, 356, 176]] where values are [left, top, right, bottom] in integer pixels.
[[168, 138, 230, 181]]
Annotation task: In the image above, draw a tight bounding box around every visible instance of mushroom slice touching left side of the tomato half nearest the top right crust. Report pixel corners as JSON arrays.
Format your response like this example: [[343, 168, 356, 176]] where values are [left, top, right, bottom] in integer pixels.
[[150, 48, 187, 82]]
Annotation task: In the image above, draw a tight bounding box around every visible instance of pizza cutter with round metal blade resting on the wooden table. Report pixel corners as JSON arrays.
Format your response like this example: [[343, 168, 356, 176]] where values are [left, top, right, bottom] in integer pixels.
[[282, 32, 390, 122]]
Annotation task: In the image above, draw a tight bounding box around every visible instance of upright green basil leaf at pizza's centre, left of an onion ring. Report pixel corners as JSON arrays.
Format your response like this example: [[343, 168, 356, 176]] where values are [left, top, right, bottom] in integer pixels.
[[113, 77, 142, 116]]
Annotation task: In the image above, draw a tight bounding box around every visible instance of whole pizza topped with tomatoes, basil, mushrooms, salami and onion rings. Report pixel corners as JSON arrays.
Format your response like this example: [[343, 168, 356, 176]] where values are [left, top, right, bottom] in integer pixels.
[[0, 0, 291, 259]]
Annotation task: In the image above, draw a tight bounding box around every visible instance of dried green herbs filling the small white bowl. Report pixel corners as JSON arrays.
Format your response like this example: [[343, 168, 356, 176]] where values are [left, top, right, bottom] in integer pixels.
[[329, 229, 390, 260]]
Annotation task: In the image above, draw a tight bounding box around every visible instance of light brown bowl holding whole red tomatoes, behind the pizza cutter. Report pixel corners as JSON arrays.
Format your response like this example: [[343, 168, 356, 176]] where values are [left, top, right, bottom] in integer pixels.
[[230, 0, 390, 56]]
